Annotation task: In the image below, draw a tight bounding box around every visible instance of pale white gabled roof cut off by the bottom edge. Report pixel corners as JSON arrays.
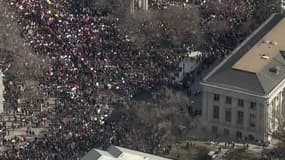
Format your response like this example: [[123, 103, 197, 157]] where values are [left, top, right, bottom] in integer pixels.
[[81, 146, 171, 160]]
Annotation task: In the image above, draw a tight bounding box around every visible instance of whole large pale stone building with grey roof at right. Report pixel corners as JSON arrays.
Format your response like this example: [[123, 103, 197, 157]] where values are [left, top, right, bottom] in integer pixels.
[[201, 15, 285, 142]]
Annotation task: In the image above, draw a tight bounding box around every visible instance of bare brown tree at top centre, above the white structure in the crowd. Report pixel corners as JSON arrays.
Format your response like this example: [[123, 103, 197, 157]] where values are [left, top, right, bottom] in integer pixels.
[[157, 5, 203, 46]]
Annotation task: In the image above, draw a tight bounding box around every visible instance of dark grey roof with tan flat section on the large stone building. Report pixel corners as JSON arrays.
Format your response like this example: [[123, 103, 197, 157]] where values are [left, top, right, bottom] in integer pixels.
[[204, 14, 285, 96]]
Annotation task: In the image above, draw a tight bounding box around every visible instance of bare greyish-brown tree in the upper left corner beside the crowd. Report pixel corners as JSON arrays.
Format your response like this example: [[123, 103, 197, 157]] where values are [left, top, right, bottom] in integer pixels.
[[0, 2, 48, 81]]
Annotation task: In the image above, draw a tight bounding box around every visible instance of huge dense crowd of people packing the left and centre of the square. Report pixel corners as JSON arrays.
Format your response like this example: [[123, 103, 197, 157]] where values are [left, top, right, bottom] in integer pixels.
[[0, 0, 260, 160]]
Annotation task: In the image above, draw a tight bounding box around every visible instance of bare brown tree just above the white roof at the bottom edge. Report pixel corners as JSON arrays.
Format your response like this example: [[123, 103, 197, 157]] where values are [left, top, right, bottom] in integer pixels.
[[115, 89, 191, 152]]
